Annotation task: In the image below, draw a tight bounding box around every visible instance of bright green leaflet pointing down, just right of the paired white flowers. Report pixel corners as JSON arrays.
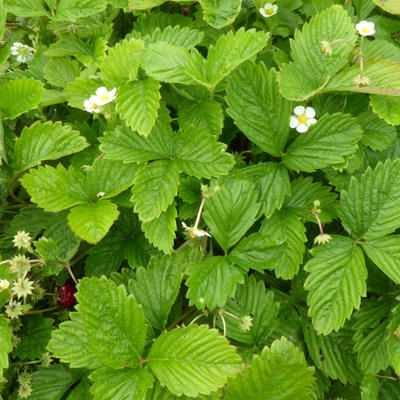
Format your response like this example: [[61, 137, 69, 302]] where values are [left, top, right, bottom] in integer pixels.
[[116, 79, 161, 136]]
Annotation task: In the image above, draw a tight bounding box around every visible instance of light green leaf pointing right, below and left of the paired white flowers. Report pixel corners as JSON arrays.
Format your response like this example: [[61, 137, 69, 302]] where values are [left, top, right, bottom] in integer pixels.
[[13, 121, 88, 173]]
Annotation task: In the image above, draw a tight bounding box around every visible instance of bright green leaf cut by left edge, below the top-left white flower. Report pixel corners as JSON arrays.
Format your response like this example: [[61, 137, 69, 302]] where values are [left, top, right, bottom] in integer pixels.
[[0, 79, 43, 119]]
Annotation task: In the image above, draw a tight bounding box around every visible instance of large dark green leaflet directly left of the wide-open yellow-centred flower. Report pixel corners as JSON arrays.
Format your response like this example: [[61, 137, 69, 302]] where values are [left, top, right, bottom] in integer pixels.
[[226, 62, 292, 157]]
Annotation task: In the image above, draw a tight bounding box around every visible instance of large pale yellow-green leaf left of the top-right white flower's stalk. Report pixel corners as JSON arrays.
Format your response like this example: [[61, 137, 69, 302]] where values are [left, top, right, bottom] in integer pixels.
[[279, 5, 360, 101]]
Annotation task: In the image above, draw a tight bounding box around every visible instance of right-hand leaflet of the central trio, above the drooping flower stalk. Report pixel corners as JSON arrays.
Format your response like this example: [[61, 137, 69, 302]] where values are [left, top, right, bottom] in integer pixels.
[[175, 129, 233, 178]]
